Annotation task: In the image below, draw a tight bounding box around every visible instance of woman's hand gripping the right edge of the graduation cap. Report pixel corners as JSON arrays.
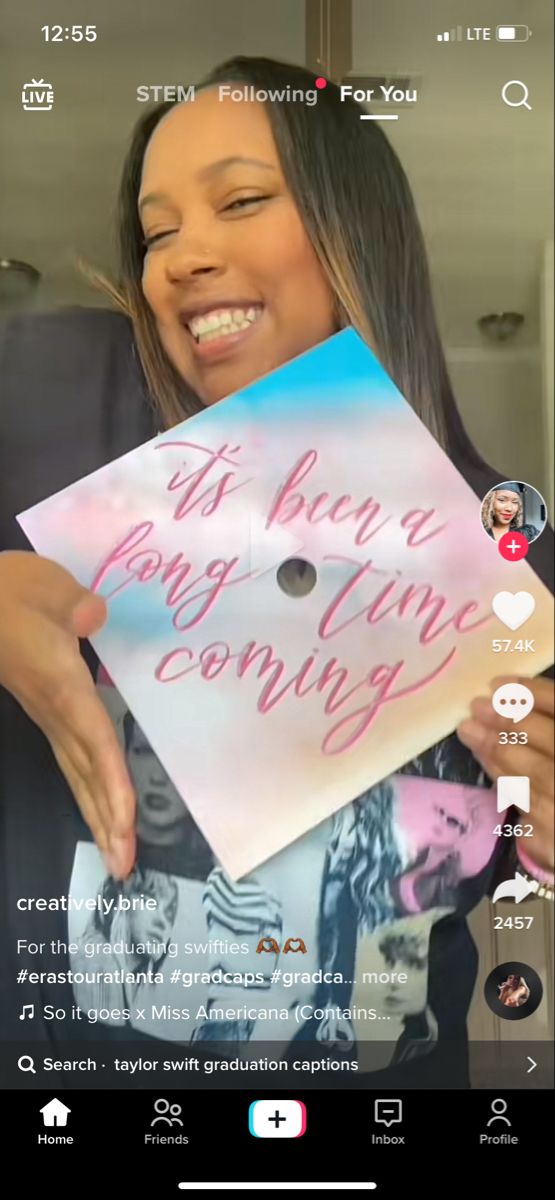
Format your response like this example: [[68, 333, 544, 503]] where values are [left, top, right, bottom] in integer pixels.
[[456, 676, 555, 871]]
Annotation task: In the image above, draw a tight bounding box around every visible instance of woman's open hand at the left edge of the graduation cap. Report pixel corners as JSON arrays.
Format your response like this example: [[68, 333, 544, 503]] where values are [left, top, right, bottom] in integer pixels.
[[0, 551, 136, 878]]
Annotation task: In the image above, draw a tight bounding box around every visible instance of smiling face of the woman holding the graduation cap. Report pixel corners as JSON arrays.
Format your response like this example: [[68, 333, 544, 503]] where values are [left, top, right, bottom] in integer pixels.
[[139, 89, 338, 404]]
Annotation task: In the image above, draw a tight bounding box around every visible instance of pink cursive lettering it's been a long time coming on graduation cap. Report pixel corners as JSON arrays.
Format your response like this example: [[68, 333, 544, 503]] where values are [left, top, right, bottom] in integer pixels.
[[91, 440, 490, 755]]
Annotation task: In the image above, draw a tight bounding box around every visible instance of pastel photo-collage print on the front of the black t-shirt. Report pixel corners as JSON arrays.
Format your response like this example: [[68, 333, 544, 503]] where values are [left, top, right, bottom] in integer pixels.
[[63, 668, 495, 1066]]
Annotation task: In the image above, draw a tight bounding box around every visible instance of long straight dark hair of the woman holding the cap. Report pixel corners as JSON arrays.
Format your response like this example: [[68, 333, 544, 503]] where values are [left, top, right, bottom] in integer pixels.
[[82, 58, 472, 456]]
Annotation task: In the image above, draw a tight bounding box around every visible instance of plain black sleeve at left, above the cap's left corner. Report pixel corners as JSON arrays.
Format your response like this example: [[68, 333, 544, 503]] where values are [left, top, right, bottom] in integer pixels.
[[0, 308, 155, 550]]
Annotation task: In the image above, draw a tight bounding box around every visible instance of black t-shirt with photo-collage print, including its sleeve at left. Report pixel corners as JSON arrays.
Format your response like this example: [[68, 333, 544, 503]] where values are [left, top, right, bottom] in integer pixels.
[[0, 310, 550, 1086]]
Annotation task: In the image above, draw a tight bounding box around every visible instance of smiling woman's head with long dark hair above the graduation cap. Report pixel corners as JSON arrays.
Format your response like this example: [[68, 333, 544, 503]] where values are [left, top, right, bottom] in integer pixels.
[[88, 58, 479, 451]]
